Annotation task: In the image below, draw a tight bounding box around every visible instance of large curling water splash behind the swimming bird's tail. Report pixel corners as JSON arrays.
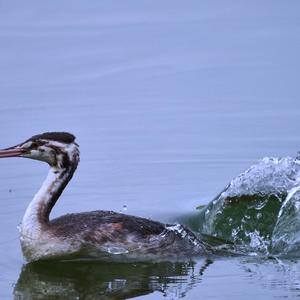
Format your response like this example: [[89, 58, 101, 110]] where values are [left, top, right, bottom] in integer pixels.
[[198, 153, 300, 254]]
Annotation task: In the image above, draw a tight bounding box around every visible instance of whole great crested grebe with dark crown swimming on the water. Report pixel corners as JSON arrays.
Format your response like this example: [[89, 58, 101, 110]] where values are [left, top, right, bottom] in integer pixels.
[[0, 132, 210, 262]]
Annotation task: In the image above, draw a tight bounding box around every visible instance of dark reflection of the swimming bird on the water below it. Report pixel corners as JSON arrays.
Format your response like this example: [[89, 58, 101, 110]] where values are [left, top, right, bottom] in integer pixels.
[[14, 259, 212, 300]]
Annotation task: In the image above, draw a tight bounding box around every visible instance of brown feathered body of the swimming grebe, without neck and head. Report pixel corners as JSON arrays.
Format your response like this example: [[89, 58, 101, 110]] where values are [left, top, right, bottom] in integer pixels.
[[21, 211, 205, 261]]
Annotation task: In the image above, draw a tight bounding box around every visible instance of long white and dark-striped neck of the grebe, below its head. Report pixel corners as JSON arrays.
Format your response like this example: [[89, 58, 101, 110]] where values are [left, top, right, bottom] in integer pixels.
[[21, 165, 77, 235]]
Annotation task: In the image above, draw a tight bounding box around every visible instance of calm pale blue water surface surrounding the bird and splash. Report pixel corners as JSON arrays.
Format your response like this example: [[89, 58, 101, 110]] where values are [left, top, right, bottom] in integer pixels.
[[0, 1, 300, 299]]
